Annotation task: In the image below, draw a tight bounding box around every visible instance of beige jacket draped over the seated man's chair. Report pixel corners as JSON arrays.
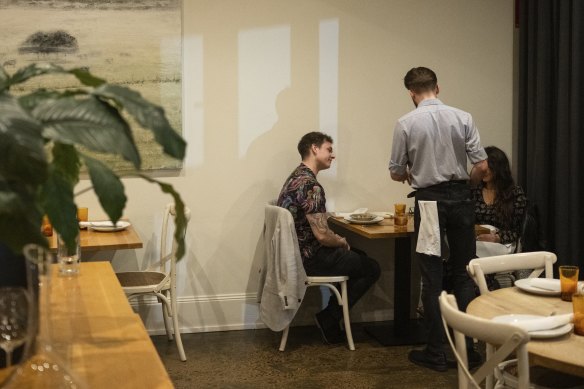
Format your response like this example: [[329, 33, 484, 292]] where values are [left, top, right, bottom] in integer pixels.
[[258, 205, 306, 331]]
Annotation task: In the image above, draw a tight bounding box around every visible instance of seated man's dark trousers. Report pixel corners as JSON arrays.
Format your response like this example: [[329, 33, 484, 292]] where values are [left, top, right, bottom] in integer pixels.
[[304, 246, 381, 320]]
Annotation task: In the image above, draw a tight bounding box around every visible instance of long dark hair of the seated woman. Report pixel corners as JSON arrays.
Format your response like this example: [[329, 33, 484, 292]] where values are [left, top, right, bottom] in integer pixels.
[[485, 146, 515, 224]]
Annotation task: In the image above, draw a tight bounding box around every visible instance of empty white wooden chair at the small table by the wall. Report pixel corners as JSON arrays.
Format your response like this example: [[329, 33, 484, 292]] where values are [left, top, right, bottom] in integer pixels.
[[116, 203, 191, 361]]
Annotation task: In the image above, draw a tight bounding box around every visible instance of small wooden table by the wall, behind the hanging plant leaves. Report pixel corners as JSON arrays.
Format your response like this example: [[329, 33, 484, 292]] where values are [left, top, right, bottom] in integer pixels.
[[49, 226, 143, 251]]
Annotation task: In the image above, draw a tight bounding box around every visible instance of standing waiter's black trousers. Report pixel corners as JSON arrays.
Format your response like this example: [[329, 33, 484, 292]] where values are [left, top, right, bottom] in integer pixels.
[[414, 181, 476, 353]]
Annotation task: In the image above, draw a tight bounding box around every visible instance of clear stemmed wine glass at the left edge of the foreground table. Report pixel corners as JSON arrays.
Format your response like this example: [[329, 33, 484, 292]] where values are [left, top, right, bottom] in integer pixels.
[[0, 287, 30, 367]]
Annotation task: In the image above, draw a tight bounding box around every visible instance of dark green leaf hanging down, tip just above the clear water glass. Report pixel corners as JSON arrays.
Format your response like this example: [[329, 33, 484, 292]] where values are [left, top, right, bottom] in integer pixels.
[[39, 165, 79, 248]]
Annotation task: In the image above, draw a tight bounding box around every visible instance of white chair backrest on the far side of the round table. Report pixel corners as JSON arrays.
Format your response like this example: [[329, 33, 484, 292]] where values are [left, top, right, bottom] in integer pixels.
[[467, 251, 557, 294]]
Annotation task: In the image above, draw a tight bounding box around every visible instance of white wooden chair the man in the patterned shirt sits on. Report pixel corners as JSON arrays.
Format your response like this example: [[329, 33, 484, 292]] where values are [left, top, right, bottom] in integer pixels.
[[261, 202, 355, 351]]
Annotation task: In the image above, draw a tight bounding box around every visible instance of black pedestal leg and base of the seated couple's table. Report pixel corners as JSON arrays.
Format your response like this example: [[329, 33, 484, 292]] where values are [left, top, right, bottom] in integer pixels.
[[365, 237, 427, 346]]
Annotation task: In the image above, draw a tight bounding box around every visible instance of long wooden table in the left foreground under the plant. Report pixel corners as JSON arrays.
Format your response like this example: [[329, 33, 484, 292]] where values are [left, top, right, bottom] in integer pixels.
[[0, 262, 173, 389]]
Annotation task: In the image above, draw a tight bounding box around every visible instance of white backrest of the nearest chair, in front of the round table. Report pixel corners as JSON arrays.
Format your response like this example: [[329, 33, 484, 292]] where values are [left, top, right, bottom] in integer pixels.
[[439, 291, 529, 389]]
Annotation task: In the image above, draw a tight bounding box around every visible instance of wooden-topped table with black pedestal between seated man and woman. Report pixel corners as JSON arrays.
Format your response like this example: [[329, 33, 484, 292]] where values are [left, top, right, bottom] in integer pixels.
[[329, 217, 426, 346]]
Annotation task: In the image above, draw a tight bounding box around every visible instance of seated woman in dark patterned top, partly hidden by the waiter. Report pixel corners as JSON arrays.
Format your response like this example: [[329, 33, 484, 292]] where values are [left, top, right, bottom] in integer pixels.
[[472, 146, 527, 257]]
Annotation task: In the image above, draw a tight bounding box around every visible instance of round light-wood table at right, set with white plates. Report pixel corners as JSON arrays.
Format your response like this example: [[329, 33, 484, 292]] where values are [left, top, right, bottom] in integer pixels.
[[467, 287, 584, 377]]
